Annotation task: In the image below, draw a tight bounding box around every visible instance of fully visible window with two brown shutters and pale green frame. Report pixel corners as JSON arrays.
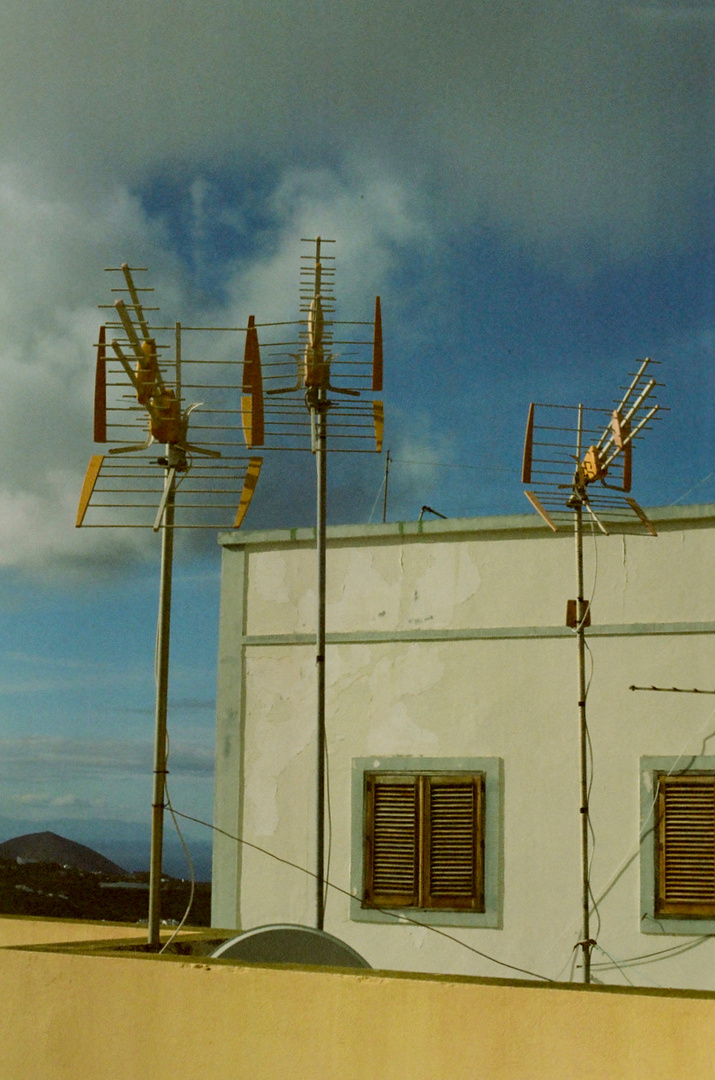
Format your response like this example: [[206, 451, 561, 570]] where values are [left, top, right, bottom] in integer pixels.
[[351, 757, 503, 928]]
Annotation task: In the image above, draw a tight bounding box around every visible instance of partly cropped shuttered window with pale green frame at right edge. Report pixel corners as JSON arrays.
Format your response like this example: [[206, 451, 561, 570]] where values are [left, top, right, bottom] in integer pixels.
[[640, 755, 715, 934]]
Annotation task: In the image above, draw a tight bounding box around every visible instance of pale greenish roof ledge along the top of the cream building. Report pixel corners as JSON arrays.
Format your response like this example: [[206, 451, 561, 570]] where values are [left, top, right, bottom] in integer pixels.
[[218, 502, 715, 548]]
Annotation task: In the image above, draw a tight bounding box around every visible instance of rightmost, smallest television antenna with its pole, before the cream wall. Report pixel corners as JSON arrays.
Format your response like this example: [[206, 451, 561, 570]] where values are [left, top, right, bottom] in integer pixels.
[[522, 357, 661, 983]]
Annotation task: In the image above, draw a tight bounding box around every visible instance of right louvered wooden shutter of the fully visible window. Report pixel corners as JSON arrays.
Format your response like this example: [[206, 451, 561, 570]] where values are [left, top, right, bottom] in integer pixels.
[[422, 773, 484, 912]]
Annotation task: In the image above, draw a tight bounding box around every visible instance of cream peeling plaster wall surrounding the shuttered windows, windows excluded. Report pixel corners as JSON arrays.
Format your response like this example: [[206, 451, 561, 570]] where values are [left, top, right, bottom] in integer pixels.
[[214, 507, 715, 989]]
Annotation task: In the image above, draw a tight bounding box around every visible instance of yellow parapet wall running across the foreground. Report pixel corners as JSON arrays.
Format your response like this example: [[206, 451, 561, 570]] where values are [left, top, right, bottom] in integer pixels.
[[0, 935, 715, 1080]]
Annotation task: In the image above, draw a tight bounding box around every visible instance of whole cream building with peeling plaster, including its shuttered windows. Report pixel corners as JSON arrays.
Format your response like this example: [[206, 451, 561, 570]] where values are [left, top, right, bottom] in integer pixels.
[[213, 505, 715, 989]]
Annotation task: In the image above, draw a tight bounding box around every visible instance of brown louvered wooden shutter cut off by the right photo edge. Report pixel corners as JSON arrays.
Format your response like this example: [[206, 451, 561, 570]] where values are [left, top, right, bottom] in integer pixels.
[[656, 773, 715, 918]]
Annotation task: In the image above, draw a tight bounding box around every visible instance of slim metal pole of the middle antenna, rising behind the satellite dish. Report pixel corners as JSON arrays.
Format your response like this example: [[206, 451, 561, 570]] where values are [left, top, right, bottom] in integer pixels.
[[312, 389, 328, 930]]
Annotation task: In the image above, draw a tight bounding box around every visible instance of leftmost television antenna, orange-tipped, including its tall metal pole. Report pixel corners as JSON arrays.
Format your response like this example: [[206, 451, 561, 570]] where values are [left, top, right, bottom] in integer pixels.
[[76, 264, 262, 946]]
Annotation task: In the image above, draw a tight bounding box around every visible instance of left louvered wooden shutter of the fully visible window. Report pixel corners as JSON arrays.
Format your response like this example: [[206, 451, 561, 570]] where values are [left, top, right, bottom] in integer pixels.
[[364, 773, 419, 907]]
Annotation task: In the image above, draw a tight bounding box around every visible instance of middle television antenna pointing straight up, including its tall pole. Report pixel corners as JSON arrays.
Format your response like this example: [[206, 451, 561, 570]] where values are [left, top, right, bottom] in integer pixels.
[[242, 237, 385, 930]]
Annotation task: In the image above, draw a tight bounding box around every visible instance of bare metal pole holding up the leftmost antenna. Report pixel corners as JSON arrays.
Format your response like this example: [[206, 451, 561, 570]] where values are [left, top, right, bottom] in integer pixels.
[[148, 464, 175, 945]]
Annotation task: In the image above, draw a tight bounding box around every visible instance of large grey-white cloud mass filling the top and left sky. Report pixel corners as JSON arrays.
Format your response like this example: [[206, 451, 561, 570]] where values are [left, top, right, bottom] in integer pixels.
[[0, 0, 715, 572]]
